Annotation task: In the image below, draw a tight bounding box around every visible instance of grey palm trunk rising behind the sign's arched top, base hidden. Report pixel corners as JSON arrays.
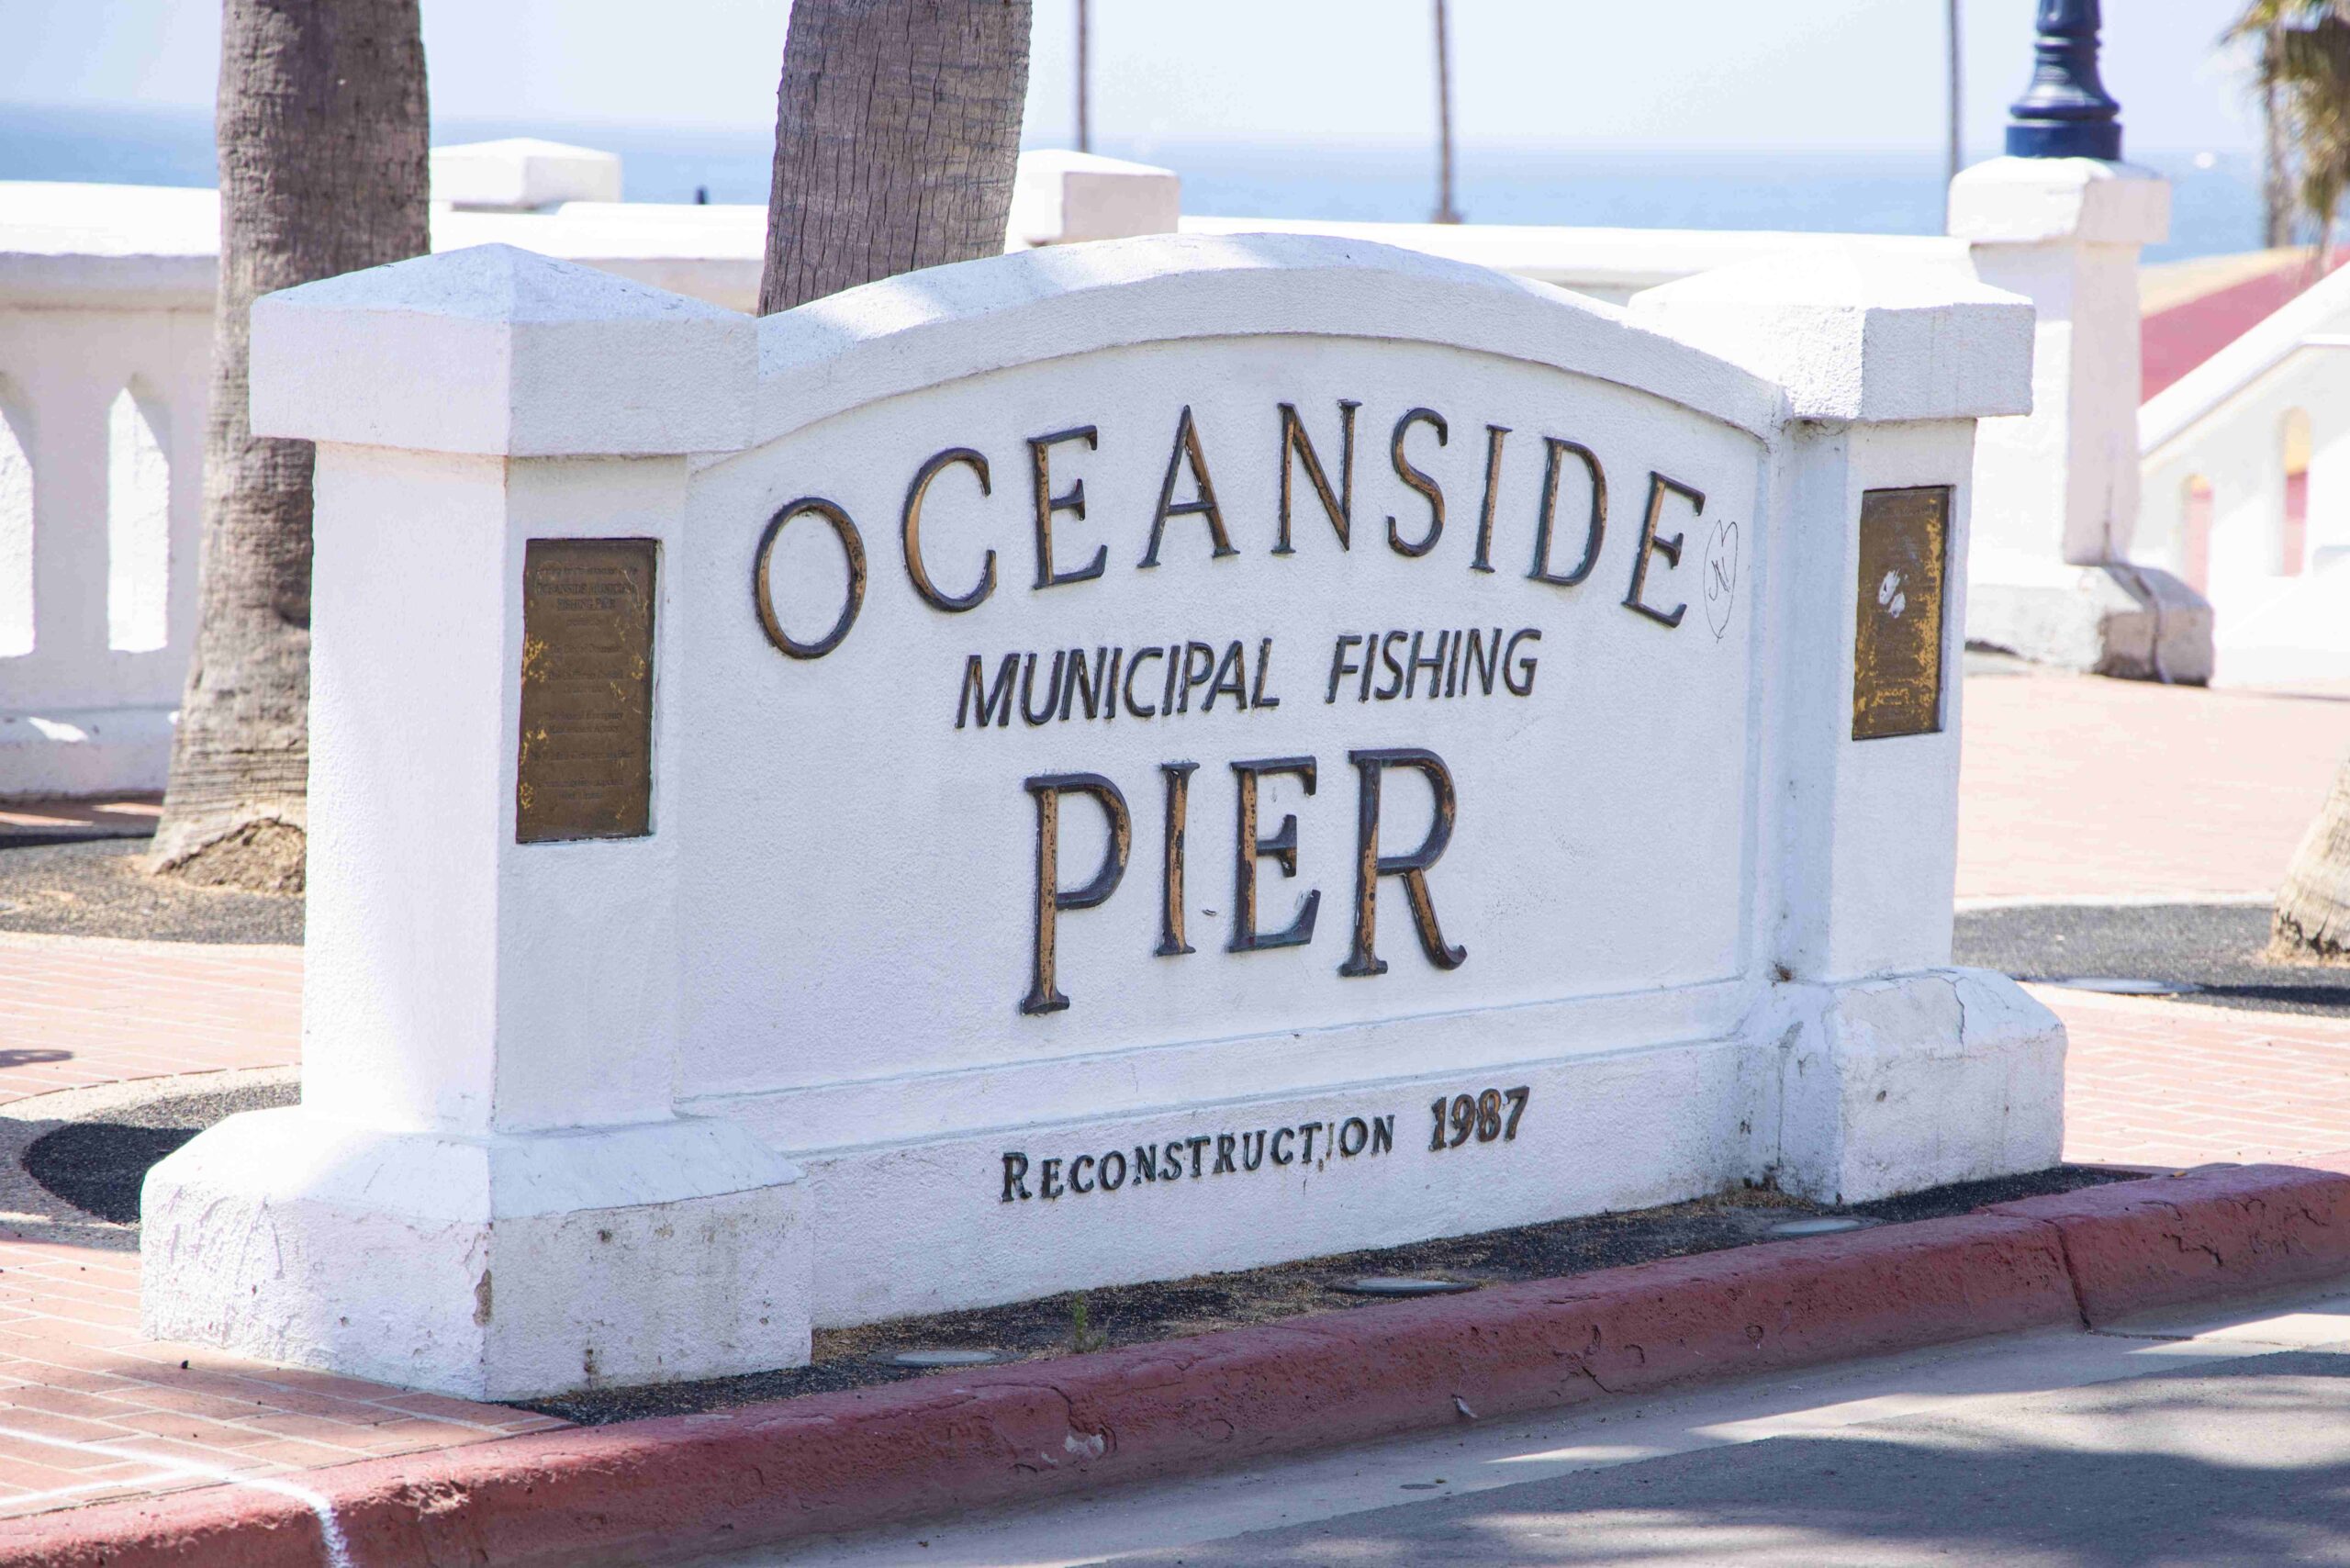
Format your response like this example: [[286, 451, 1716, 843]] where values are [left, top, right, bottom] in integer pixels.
[[759, 0, 1029, 315]]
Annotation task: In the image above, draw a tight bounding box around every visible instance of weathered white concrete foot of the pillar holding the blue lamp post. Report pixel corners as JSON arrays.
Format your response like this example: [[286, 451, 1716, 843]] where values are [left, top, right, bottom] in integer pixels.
[[1967, 565, 2211, 687]]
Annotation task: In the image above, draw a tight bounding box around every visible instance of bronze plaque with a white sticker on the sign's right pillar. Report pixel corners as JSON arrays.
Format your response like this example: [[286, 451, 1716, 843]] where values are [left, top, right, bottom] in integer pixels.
[[1852, 485, 1951, 741]]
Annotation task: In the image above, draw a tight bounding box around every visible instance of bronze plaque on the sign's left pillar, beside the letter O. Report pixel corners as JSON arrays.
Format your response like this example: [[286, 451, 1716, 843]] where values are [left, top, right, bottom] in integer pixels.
[[515, 538, 654, 844]]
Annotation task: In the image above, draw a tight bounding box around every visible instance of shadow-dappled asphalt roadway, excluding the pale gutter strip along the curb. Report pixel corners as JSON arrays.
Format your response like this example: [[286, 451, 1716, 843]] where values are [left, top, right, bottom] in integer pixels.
[[1116, 1351, 2350, 1568]]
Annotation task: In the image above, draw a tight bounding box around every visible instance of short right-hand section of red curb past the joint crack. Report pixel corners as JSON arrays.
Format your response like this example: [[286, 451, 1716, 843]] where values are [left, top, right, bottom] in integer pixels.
[[1986, 1166, 2350, 1324]]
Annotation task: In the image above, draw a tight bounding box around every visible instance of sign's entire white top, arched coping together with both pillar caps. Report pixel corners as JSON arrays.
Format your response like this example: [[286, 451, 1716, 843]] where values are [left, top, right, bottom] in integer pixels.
[[252, 235, 2032, 458]]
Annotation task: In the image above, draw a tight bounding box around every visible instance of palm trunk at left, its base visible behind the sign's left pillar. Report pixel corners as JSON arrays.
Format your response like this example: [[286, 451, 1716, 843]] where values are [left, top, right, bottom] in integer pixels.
[[148, 0, 430, 891]]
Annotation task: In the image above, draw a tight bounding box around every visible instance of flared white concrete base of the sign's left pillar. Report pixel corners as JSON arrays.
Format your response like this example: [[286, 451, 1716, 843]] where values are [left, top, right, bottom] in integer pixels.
[[139, 1107, 809, 1399]]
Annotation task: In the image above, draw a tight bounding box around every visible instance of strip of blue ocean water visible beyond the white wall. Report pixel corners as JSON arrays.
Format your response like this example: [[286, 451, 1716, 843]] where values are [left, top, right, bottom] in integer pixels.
[[0, 106, 2261, 261]]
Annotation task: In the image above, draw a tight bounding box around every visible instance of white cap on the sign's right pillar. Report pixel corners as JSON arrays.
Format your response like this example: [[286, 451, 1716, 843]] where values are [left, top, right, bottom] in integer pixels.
[[1631, 240, 2032, 423]]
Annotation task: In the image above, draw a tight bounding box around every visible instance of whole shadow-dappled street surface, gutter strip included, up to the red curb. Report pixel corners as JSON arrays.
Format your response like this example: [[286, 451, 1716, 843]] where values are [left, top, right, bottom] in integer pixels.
[[712, 1282, 2350, 1568]]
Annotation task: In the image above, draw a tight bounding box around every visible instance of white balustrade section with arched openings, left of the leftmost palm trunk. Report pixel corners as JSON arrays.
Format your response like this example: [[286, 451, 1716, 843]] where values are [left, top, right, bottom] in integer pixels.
[[0, 185, 217, 795]]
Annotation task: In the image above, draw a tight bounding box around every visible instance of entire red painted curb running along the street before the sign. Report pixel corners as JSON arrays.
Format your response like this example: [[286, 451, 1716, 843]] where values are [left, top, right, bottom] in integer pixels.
[[0, 1166, 2350, 1568]]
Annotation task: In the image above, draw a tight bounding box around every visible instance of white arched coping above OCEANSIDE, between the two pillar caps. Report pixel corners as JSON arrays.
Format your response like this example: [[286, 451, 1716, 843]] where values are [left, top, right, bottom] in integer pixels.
[[752, 235, 1784, 444]]
